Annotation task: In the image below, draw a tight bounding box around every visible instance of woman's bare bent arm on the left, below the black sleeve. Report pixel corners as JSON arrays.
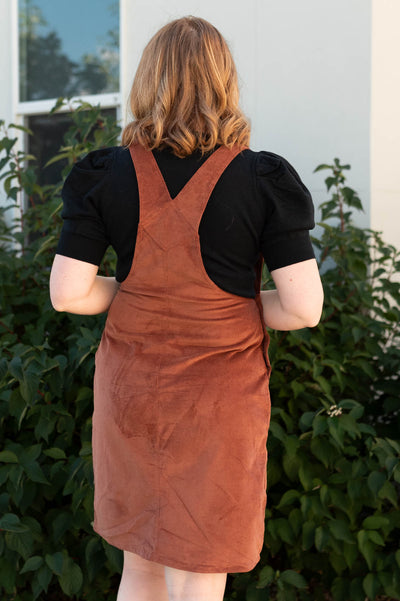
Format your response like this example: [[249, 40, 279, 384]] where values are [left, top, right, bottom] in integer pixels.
[[50, 255, 119, 315]]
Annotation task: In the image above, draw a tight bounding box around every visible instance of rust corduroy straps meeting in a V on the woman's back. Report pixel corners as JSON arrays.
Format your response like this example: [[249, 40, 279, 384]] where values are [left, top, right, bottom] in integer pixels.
[[129, 144, 243, 232]]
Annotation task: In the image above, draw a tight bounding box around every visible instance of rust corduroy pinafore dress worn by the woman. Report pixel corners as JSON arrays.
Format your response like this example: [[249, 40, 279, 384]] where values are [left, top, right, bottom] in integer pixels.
[[93, 145, 270, 572]]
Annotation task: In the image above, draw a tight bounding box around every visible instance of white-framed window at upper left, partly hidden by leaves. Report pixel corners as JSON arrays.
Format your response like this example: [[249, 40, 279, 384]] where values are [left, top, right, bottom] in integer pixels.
[[16, 0, 120, 183]]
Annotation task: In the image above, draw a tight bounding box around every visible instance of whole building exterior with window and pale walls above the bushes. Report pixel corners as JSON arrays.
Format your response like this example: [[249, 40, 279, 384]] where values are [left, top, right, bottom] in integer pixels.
[[0, 0, 400, 247]]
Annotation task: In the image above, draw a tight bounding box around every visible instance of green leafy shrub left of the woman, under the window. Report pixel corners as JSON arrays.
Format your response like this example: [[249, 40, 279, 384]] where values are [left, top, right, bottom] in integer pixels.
[[0, 101, 122, 601]]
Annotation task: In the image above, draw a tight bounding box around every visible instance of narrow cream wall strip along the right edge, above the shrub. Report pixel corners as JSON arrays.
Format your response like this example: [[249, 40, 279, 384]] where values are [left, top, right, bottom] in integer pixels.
[[371, 0, 400, 249]]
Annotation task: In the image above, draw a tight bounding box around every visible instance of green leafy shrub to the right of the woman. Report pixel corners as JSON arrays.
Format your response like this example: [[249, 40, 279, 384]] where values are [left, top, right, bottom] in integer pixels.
[[231, 159, 400, 601]]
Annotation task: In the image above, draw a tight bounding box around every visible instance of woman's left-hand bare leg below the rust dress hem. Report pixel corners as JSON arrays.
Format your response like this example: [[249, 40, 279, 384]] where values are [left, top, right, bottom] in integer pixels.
[[117, 551, 168, 601]]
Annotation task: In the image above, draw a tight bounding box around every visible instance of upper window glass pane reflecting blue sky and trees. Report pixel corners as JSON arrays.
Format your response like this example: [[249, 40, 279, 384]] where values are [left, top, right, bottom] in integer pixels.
[[19, 0, 119, 102]]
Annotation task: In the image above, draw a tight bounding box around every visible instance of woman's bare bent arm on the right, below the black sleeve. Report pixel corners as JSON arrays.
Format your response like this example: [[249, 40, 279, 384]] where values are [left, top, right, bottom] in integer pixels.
[[261, 259, 324, 330]]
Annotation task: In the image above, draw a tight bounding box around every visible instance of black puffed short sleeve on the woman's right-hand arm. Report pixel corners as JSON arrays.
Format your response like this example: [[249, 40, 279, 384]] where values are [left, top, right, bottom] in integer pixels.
[[256, 152, 315, 271]]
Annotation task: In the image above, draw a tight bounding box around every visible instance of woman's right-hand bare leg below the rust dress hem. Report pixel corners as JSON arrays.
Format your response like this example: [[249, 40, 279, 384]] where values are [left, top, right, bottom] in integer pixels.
[[165, 567, 226, 601]]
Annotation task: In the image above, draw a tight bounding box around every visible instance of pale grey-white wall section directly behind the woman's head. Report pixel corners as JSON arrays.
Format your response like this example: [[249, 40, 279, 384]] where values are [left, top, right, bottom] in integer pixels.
[[122, 0, 372, 226]]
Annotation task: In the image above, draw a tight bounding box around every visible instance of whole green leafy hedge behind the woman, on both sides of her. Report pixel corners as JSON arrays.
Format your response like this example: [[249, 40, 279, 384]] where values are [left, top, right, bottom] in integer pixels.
[[0, 101, 400, 601]]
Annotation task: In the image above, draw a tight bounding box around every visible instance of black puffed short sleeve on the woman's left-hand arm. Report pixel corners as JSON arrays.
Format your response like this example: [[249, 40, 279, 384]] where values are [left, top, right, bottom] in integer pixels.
[[56, 148, 114, 265]]
